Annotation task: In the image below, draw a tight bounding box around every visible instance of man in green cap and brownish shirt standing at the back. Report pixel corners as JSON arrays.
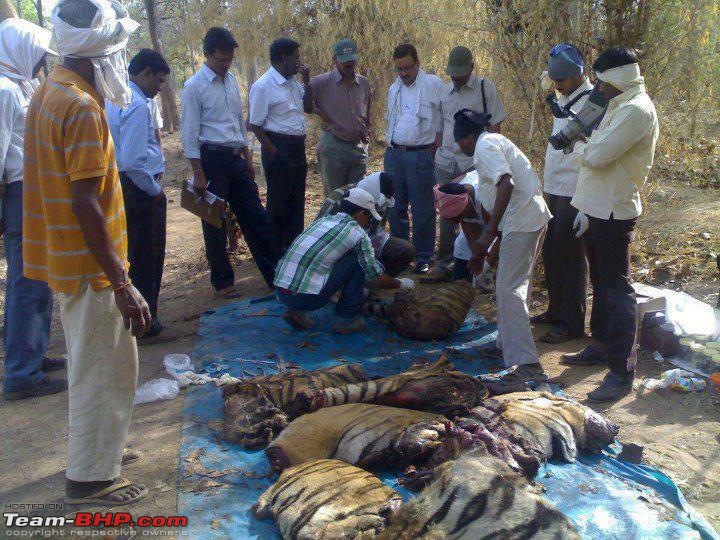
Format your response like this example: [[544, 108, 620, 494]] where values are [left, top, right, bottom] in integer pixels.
[[310, 39, 370, 196]]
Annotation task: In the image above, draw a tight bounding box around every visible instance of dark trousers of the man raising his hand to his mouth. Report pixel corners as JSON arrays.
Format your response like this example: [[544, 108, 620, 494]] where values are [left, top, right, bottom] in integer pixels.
[[261, 133, 307, 252]]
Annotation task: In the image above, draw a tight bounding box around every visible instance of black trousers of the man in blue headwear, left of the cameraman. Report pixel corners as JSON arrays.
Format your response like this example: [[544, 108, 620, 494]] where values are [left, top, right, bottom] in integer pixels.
[[543, 194, 588, 337]]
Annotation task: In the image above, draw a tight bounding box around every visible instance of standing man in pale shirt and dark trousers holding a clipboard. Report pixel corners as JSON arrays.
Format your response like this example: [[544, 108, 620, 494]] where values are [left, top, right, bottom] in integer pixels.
[[182, 28, 280, 298]]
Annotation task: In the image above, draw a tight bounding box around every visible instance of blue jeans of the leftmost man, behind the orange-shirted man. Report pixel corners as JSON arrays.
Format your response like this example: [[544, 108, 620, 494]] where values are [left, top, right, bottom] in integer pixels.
[[2, 182, 53, 392]]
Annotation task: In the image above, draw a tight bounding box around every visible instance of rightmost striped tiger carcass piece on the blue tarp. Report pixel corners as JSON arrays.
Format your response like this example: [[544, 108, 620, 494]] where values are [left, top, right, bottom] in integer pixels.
[[473, 392, 619, 462]]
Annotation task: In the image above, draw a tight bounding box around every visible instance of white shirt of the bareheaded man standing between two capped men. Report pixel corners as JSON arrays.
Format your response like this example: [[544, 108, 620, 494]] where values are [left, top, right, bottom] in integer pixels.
[[386, 69, 443, 146]]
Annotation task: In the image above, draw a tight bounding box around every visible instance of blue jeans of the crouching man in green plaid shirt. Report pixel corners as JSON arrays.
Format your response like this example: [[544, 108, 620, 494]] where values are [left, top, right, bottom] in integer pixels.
[[278, 251, 365, 319]]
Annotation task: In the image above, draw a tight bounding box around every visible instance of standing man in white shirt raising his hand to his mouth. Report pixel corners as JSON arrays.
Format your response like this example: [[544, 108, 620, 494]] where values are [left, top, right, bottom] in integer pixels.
[[248, 38, 313, 250]]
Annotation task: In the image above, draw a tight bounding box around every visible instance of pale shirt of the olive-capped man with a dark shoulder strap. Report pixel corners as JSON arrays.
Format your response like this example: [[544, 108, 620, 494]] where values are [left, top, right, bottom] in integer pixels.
[[435, 74, 506, 172]]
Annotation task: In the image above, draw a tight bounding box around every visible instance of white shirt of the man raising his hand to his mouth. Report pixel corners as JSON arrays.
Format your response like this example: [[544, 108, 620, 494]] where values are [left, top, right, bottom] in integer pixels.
[[249, 67, 307, 135]]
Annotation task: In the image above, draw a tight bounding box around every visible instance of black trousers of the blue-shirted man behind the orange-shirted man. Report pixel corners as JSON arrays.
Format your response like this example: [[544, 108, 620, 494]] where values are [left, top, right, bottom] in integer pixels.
[[120, 173, 167, 319]]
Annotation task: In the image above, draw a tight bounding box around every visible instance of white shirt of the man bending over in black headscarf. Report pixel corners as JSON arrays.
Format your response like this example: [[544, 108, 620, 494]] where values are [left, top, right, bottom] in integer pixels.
[[474, 132, 552, 234]]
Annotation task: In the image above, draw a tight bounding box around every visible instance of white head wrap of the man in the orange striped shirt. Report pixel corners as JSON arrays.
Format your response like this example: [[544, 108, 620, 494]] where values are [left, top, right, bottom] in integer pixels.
[[50, 0, 140, 107]]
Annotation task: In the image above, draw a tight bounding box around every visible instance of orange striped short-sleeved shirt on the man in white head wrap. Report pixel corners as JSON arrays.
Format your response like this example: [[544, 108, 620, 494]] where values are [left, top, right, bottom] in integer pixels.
[[23, 66, 127, 294]]
